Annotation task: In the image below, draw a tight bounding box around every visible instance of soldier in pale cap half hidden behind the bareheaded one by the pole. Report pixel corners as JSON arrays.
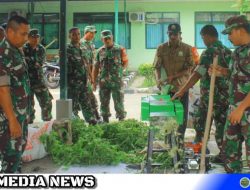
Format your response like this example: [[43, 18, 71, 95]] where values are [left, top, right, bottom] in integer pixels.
[[81, 26, 101, 121]]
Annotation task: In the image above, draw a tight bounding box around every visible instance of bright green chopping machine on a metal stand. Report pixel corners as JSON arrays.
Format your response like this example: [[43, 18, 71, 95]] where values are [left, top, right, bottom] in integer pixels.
[[141, 85, 184, 173]]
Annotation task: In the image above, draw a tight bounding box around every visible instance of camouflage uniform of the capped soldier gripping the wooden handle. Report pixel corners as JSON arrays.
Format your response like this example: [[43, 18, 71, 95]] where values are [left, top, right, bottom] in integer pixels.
[[223, 44, 250, 173]]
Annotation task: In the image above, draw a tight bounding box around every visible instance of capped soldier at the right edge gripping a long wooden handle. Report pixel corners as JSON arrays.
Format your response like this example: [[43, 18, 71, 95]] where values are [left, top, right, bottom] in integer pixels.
[[214, 15, 250, 173]]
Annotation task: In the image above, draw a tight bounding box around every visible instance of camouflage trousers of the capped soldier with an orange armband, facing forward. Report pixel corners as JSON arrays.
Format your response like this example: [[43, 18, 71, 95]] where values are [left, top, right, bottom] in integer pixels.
[[99, 84, 126, 119]]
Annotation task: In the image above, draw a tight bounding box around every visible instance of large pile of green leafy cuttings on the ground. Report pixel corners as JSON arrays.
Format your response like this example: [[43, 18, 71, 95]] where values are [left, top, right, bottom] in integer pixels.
[[41, 119, 148, 166]]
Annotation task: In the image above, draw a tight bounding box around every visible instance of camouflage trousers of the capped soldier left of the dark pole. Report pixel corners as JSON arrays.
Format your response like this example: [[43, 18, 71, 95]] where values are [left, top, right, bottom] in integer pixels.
[[30, 85, 53, 123]]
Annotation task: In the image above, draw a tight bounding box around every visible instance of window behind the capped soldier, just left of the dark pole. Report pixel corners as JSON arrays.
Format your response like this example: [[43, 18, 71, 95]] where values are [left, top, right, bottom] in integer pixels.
[[29, 13, 59, 49]]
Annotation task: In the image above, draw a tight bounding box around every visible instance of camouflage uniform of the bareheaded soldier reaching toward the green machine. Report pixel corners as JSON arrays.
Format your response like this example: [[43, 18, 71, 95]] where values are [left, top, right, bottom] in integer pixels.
[[194, 41, 231, 154]]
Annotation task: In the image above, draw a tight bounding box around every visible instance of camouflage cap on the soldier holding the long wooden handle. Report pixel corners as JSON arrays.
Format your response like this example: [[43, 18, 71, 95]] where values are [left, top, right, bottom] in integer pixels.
[[221, 15, 250, 34]]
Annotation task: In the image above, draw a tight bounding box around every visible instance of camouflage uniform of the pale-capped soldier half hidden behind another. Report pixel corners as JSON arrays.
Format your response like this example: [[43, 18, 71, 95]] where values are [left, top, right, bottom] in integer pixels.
[[81, 39, 100, 119]]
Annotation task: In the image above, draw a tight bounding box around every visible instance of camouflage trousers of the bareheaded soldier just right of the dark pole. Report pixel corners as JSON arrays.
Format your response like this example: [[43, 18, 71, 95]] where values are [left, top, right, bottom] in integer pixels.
[[68, 85, 96, 122]]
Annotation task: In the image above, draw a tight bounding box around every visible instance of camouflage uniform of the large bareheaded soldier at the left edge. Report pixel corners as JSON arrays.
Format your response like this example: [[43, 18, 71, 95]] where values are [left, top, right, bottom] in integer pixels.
[[0, 40, 30, 173]]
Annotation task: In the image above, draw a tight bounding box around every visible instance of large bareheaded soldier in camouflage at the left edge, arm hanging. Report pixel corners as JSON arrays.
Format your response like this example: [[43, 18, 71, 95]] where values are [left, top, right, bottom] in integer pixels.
[[0, 16, 30, 173]]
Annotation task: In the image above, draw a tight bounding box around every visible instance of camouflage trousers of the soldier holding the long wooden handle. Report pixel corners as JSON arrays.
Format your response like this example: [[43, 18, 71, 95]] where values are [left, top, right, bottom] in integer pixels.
[[222, 109, 250, 173]]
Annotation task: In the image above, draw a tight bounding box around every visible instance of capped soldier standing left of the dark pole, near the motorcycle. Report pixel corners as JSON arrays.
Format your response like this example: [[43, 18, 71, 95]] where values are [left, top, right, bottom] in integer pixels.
[[23, 29, 53, 123]]
